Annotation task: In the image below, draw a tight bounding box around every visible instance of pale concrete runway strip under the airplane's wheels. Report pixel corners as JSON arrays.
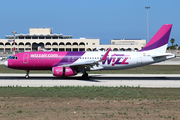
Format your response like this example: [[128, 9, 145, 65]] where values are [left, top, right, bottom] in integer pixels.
[[0, 74, 180, 88]]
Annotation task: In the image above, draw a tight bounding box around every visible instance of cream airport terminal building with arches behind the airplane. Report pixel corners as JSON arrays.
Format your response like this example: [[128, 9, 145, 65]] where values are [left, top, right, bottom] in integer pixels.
[[0, 28, 146, 53]]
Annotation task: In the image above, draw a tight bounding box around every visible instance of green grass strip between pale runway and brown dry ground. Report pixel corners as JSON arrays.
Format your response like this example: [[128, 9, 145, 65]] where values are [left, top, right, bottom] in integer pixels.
[[0, 86, 180, 100]]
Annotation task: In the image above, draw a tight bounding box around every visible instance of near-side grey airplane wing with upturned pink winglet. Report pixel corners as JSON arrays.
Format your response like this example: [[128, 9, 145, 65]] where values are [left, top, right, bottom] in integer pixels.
[[63, 48, 111, 69]]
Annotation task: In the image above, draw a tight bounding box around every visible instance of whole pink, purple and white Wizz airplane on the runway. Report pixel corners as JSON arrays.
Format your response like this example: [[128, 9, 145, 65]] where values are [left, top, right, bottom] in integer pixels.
[[4, 24, 176, 79]]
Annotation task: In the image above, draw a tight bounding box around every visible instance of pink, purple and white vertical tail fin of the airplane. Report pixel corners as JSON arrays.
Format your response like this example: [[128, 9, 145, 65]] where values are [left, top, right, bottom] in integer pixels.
[[139, 24, 172, 53]]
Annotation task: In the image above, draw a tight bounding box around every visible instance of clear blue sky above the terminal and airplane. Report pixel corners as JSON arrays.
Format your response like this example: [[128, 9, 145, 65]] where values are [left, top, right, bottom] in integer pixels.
[[0, 0, 180, 46]]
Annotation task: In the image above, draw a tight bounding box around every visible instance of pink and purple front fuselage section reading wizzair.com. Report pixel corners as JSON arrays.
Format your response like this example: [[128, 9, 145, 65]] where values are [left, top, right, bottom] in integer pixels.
[[6, 51, 85, 70]]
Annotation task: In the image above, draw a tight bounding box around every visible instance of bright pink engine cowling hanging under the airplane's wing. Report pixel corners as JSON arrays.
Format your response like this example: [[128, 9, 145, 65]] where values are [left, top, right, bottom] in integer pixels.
[[52, 67, 76, 77]]
